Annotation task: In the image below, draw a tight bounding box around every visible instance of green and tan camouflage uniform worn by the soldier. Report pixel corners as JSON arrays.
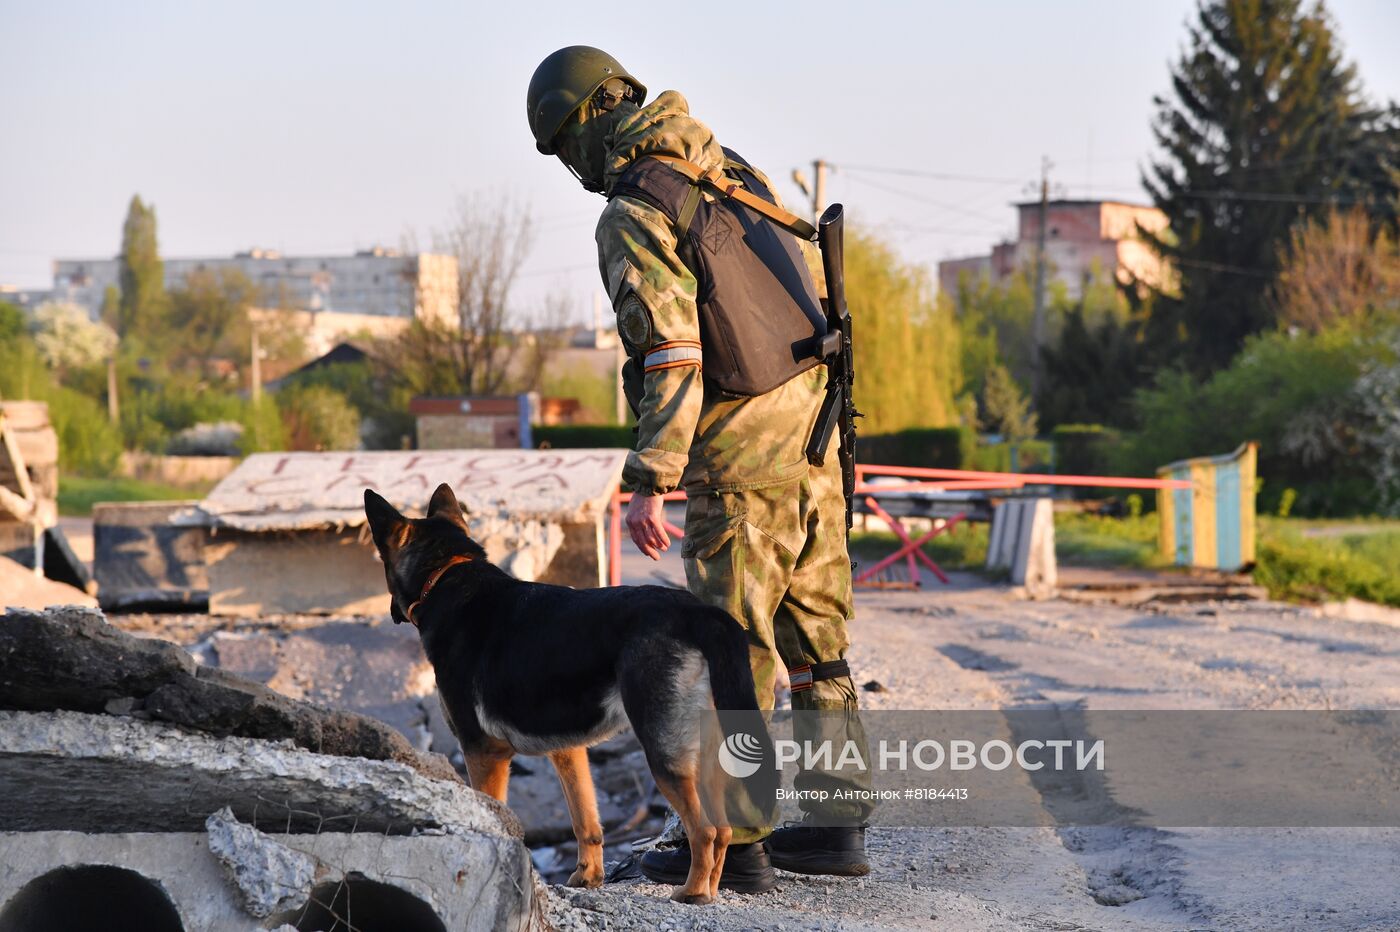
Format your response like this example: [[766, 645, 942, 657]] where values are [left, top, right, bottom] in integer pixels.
[[564, 91, 869, 842]]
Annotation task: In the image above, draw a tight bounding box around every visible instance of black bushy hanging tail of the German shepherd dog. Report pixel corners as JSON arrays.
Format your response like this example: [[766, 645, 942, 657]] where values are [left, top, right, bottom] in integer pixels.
[[694, 609, 783, 827]]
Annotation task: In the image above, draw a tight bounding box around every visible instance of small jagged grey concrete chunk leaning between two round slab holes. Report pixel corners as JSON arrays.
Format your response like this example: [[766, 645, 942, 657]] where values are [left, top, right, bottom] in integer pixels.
[[204, 806, 316, 919]]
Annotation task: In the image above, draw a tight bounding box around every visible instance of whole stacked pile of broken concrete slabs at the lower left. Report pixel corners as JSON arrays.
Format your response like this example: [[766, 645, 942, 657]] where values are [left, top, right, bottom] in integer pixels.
[[0, 607, 547, 932]]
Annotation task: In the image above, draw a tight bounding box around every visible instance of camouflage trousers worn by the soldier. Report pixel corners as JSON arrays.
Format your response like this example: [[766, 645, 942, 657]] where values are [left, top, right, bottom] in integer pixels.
[[680, 456, 872, 844]]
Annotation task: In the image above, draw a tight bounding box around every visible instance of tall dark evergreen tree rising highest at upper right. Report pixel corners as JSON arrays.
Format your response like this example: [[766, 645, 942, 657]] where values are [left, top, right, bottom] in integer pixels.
[[1144, 0, 1400, 374]]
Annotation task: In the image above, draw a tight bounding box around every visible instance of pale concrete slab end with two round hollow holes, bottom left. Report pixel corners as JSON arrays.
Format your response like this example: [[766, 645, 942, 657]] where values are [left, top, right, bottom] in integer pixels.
[[0, 806, 550, 932]]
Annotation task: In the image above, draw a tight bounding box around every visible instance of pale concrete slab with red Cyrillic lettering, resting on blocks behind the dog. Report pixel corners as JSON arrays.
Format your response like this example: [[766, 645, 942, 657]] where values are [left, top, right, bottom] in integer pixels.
[[175, 449, 626, 617]]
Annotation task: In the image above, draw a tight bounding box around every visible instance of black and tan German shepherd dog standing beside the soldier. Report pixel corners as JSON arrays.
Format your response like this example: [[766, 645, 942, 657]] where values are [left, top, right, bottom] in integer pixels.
[[364, 484, 771, 903]]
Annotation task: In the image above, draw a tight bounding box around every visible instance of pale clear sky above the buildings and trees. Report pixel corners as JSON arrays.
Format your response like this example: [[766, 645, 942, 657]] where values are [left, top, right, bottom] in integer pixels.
[[0, 0, 1400, 320]]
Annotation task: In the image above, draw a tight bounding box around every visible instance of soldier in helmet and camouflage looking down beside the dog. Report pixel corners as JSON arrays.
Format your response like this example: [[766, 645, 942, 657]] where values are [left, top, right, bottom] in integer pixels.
[[526, 46, 871, 893]]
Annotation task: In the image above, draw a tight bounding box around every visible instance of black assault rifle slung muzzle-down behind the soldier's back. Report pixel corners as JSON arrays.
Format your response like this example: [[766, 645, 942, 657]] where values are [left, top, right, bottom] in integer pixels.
[[806, 204, 861, 533]]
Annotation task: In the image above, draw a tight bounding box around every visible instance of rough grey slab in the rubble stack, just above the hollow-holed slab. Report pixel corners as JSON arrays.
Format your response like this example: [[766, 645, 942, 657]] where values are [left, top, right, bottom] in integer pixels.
[[0, 712, 522, 838]]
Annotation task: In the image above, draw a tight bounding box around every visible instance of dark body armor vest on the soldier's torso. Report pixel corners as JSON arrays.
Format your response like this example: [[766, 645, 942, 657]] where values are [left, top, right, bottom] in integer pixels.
[[609, 148, 827, 396]]
